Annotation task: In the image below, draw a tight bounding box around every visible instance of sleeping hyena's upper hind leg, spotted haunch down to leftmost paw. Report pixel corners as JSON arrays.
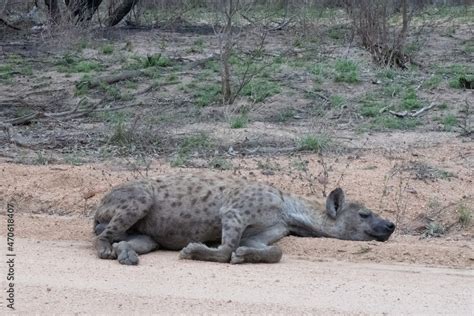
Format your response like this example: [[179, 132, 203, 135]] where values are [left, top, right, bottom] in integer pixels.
[[95, 182, 153, 259]]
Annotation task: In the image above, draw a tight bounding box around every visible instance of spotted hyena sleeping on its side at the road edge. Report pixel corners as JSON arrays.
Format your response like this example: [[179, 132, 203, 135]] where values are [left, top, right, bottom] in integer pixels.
[[94, 173, 395, 264]]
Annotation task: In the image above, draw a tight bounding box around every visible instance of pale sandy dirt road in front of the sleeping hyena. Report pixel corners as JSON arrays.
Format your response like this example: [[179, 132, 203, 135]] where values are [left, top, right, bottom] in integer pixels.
[[3, 238, 474, 315]]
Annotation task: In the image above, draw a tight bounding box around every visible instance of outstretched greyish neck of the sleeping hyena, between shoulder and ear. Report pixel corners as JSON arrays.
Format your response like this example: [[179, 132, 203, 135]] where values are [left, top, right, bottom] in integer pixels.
[[283, 195, 338, 238]]
